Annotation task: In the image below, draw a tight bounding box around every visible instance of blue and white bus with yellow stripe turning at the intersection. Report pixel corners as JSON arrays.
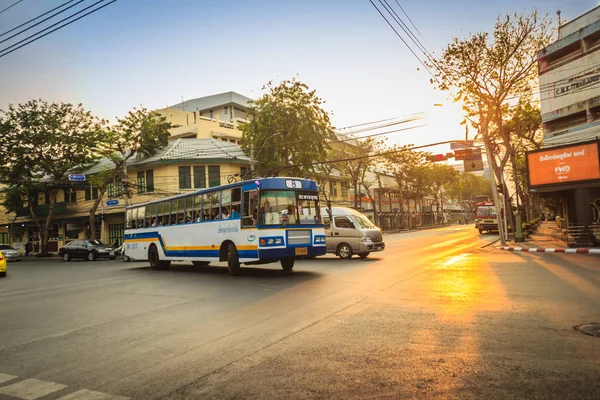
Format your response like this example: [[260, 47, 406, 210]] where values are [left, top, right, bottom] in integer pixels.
[[124, 178, 327, 275]]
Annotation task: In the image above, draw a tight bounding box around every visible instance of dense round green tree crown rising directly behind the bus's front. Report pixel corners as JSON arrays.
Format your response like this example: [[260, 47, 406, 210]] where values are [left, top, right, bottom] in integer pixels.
[[241, 78, 335, 176]]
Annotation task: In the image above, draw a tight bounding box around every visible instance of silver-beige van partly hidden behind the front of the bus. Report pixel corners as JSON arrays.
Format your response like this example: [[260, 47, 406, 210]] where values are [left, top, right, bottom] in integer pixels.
[[321, 207, 385, 259]]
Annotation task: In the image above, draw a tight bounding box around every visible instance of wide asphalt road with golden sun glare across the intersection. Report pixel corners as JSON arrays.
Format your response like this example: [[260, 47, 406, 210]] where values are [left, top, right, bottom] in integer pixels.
[[0, 226, 600, 400]]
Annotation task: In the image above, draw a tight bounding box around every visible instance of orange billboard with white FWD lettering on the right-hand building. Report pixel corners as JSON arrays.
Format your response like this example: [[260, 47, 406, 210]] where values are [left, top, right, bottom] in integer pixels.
[[527, 141, 600, 189]]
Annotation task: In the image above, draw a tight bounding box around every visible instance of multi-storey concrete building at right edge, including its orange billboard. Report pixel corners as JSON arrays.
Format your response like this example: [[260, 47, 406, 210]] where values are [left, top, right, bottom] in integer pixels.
[[527, 6, 600, 243]]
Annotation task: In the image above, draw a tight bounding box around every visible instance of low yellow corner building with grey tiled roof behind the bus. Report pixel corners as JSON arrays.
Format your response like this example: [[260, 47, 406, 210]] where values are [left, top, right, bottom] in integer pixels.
[[4, 139, 250, 252]]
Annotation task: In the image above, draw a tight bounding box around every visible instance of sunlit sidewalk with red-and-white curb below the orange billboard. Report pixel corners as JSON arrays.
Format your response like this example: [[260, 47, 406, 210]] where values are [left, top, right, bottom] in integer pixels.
[[498, 221, 600, 254]]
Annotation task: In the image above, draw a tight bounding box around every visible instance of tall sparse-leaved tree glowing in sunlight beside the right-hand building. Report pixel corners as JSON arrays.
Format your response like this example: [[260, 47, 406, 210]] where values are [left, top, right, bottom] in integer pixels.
[[429, 11, 554, 231]]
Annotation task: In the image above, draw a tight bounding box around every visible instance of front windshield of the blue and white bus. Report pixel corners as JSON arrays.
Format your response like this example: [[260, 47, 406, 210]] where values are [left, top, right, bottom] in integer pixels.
[[259, 190, 321, 226]]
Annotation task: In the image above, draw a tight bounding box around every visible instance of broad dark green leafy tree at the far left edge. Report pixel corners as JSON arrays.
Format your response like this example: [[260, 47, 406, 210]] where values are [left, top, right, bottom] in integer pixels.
[[0, 100, 102, 254]]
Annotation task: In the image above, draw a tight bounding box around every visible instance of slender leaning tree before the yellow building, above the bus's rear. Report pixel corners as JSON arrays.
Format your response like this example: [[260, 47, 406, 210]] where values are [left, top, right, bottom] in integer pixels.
[[89, 108, 173, 236]]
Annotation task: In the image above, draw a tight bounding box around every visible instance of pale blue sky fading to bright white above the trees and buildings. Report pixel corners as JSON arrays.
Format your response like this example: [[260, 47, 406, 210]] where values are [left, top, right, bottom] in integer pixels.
[[0, 0, 598, 155]]
